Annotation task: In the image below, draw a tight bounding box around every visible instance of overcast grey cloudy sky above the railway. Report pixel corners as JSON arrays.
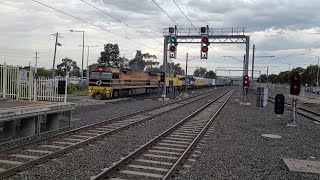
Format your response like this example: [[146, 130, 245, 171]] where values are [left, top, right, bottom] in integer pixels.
[[0, 0, 320, 75]]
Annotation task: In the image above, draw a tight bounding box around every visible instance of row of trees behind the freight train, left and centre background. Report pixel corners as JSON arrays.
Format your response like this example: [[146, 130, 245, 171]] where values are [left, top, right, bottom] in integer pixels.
[[24, 43, 215, 78]]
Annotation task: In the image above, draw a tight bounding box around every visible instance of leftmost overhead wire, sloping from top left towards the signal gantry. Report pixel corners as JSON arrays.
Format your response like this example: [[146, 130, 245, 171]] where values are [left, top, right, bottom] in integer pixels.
[[32, 0, 162, 52]]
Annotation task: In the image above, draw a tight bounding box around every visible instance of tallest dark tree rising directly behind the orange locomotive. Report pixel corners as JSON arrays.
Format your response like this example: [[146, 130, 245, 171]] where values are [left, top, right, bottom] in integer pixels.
[[98, 43, 127, 67]]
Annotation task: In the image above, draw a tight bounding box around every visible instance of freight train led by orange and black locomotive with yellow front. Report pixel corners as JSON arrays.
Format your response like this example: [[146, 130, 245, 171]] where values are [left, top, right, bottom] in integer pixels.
[[88, 66, 230, 99]]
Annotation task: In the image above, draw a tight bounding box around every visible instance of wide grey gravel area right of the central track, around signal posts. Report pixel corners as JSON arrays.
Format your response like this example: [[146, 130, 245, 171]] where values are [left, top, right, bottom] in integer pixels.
[[177, 88, 320, 180]]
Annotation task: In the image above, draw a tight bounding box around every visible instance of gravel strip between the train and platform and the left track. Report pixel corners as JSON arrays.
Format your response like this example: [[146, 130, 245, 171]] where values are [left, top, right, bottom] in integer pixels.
[[0, 88, 221, 151]]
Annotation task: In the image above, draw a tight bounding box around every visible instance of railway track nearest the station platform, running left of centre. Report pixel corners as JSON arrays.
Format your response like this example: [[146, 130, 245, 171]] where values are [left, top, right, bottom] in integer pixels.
[[0, 89, 230, 179]]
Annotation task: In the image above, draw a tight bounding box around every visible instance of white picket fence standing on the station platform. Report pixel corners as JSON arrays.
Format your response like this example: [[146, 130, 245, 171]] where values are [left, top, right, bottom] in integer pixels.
[[0, 63, 65, 102]]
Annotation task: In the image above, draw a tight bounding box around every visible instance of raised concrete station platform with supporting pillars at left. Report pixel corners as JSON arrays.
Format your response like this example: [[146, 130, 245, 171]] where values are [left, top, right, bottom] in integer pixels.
[[0, 99, 76, 139]]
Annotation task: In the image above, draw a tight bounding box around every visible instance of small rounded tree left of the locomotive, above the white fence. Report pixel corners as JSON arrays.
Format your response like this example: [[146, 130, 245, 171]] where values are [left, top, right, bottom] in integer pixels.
[[56, 57, 80, 76]]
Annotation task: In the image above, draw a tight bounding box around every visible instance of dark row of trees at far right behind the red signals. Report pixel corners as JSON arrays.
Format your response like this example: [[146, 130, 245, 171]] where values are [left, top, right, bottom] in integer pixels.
[[258, 65, 318, 86]]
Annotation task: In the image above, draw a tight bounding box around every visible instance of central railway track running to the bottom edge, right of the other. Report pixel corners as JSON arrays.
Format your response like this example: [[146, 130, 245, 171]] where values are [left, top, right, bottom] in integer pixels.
[[93, 90, 234, 180]]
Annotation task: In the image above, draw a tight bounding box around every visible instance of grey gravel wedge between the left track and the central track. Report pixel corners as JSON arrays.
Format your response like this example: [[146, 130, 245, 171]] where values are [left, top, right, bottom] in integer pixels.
[[8, 88, 230, 180]]
